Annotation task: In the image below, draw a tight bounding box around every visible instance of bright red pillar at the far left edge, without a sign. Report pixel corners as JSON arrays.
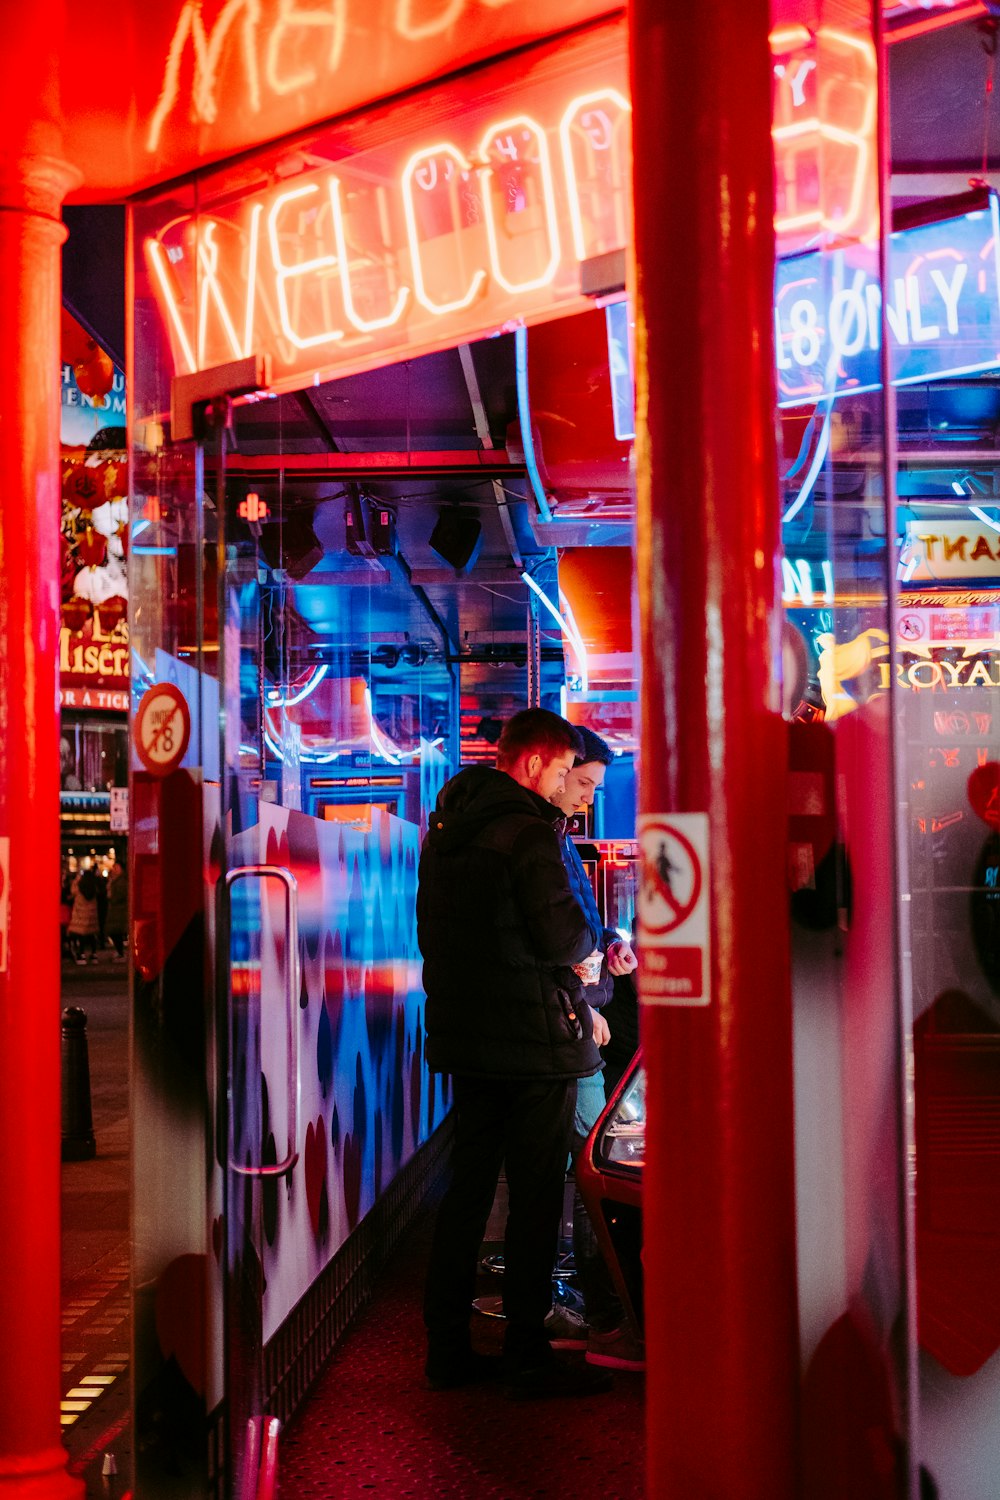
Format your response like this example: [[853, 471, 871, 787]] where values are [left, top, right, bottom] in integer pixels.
[[0, 5, 82, 1500]]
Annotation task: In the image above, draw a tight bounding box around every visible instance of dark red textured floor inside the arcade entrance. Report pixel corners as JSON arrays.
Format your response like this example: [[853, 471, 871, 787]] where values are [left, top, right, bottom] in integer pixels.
[[280, 1212, 645, 1500]]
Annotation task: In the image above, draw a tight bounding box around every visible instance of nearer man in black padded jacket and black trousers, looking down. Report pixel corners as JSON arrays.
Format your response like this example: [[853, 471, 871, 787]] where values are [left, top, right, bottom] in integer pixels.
[[417, 708, 607, 1397]]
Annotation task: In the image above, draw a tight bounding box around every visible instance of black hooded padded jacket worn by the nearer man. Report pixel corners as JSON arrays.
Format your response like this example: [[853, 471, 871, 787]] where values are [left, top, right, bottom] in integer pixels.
[[417, 767, 601, 1079]]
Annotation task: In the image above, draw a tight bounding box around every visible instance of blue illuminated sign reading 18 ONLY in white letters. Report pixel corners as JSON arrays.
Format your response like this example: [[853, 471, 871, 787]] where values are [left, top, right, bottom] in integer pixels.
[[774, 194, 1000, 407]]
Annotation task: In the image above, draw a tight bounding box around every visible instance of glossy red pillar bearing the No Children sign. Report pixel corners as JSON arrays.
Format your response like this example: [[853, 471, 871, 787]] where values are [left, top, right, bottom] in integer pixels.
[[630, 0, 798, 1500]]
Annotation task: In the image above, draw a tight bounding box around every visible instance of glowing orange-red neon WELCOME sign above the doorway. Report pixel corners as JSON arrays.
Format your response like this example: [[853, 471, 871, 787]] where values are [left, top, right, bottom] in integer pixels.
[[142, 26, 631, 399]]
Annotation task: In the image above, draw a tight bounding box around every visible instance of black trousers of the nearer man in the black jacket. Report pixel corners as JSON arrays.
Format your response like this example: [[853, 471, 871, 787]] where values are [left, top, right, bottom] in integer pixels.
[[424, 1077, 576, 1368]]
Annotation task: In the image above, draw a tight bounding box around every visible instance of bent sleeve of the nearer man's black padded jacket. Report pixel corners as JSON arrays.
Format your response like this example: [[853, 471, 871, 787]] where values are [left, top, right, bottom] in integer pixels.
[[511, 822, 601, 968]]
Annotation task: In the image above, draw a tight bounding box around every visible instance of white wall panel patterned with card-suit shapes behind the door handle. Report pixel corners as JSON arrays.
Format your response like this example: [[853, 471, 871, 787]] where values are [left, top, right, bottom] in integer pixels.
[[231, 804, 447, 1338]]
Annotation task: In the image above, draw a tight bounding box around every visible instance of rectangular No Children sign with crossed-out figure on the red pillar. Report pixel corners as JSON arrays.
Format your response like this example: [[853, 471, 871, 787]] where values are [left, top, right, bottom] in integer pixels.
[[636, 813, 711, 1005]]
